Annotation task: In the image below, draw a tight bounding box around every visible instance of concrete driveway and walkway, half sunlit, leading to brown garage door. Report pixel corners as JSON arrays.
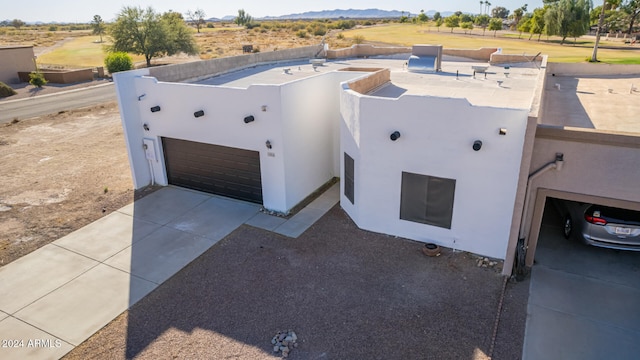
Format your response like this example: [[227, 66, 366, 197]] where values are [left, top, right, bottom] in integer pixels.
[[0, 184, 340, 359]]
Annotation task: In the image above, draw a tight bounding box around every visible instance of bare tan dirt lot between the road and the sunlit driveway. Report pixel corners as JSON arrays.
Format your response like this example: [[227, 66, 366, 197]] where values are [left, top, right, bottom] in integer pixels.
[[0, 102, 156, 266]]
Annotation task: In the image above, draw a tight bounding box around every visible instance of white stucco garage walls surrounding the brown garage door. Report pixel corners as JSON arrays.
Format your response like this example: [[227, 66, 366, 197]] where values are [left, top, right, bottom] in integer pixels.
[[115, 65, 363, 213]]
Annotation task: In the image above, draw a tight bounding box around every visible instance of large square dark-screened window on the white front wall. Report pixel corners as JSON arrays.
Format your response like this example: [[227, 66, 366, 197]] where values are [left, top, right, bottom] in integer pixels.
[[400, 172, 456, 229]]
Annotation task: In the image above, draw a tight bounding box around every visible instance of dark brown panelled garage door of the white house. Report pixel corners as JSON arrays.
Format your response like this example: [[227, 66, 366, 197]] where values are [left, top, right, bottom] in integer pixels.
[[162, 138, 262, 204]]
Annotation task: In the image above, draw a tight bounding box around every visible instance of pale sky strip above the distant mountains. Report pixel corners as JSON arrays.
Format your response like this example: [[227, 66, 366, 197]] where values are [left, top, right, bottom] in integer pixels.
[[0, 0, 542, 23]]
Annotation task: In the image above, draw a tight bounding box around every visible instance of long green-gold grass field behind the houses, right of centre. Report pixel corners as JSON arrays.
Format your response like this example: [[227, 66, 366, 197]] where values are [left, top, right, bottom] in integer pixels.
[[343, 24, 640, 64]]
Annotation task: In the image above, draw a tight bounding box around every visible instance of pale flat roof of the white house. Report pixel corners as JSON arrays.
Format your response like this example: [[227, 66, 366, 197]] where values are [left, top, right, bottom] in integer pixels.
[[195, 53, 541, 110]]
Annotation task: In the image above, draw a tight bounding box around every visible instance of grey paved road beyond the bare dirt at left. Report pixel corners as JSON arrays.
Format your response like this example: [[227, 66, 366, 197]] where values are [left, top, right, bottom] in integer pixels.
[[0, 83, 116, 124]]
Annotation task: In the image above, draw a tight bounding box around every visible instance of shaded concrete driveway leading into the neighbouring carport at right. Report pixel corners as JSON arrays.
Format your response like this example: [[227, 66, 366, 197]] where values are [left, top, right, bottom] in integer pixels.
[[523, 207, 640, 360]]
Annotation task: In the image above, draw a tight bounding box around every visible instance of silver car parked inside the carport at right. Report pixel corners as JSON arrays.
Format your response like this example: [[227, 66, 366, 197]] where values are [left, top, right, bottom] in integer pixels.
[[553, 199, 640, 251]]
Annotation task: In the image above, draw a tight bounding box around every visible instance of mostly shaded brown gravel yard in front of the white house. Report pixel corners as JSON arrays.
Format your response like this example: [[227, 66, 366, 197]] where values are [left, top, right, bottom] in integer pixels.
[[67, 206, 527, 359]]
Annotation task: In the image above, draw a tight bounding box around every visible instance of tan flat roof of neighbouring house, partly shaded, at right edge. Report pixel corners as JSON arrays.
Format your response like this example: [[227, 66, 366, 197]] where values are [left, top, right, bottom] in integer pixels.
[[540, 74, 640, 133]]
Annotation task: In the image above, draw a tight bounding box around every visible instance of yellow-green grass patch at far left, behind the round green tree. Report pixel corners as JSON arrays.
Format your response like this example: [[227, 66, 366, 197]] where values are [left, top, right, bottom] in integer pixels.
[[38, 36, 144, 67]]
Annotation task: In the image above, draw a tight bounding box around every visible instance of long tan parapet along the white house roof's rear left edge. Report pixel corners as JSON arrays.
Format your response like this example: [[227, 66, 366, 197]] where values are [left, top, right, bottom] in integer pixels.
[[149, 45, 323, 82]]
